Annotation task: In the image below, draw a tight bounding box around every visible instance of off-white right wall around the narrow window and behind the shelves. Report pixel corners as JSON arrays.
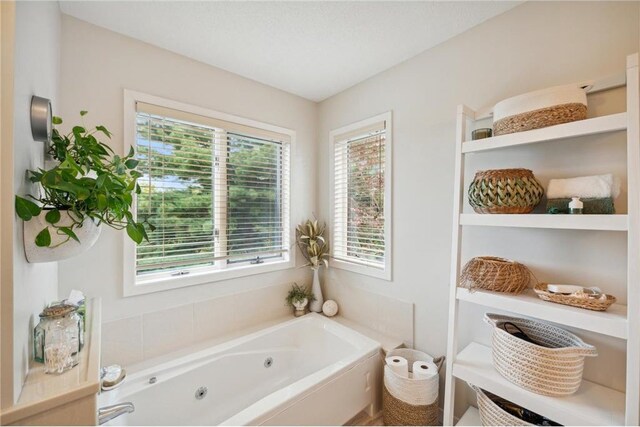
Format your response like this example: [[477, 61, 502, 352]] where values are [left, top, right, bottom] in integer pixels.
[[317, 2, 639, 414]]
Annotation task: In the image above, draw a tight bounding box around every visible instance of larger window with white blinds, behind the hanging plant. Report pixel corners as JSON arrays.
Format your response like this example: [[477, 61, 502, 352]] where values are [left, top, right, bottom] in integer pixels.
[[125, 91, 292, 294]]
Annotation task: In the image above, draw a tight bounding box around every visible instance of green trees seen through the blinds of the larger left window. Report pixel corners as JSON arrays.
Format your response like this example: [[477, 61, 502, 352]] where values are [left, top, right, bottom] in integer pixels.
[[136, 112, 285, 274]]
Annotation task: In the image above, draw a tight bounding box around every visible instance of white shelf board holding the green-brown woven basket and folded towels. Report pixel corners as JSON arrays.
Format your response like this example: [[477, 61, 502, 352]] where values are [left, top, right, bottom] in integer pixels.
[[460, 214, 629, 231]]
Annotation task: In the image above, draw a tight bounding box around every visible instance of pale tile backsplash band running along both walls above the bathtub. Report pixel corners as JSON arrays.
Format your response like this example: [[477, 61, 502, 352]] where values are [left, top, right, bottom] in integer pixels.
[[102, 283, 413, 366]]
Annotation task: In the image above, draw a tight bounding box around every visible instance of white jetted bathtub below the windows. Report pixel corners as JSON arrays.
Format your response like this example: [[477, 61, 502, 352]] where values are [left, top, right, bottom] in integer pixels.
[[99, 314, 381, 425]]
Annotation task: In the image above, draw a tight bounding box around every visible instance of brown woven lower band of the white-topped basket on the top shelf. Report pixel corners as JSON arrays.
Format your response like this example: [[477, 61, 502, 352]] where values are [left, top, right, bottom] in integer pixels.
[[493, 102, 587, 136]]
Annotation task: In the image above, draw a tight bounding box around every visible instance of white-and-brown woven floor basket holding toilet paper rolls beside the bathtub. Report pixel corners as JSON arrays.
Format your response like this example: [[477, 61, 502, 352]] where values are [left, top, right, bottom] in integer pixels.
[[382, 348, 444, 426]]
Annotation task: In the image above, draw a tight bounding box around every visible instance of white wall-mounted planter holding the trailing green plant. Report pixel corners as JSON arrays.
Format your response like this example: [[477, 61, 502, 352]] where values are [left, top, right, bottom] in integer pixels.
[[23, 210, 101, 263]]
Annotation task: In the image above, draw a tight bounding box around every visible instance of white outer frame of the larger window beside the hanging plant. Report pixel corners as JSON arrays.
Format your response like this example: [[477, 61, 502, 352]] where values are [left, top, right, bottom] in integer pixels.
[[122, 89, 297, 297]]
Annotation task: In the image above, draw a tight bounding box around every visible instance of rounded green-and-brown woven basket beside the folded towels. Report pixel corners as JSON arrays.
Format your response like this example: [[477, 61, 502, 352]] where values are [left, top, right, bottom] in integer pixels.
[[468, 169, 544, 214]]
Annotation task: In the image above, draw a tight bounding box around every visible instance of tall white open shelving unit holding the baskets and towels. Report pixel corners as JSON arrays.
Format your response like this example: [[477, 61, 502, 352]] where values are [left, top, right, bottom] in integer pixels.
[[444, 54, 640, 425]]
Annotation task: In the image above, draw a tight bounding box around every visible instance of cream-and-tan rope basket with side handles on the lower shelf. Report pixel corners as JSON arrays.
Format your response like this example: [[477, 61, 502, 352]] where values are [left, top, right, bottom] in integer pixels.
[[484, 313, 598, 396]]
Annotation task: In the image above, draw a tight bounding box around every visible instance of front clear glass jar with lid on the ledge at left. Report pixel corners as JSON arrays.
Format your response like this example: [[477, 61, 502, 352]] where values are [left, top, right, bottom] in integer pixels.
[[33, 303, 84, 373]]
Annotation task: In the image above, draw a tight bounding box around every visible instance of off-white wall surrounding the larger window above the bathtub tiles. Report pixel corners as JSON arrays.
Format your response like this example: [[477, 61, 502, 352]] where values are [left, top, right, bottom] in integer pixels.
[[56, 16, 317, 322]]
